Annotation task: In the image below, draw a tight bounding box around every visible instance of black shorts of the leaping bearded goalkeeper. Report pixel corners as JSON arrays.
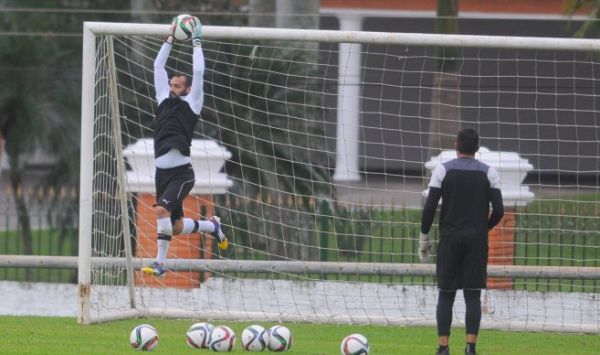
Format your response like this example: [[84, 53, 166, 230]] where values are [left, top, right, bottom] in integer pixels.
[[154, 164, 195, 222]]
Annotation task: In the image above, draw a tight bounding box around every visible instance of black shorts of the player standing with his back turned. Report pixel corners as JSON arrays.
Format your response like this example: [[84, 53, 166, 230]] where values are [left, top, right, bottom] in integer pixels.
[[436, 236, 488, 290]]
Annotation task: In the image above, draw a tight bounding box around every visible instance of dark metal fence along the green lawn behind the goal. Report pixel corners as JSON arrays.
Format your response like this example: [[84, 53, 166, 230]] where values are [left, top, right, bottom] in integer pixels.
[[0, 188, 600, 292]]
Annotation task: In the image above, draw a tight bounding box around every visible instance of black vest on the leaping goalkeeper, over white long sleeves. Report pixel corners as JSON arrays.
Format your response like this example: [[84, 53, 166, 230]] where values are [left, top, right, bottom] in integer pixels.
[[154, 97, 198, 158]]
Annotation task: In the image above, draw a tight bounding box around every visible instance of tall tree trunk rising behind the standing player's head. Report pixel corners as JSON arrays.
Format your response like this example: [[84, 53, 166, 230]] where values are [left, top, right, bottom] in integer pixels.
[[429, 0, 461, 157]]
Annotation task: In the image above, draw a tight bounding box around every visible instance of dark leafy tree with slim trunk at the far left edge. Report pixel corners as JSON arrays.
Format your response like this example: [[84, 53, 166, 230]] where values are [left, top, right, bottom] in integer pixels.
[[0, 4, 74, 280]]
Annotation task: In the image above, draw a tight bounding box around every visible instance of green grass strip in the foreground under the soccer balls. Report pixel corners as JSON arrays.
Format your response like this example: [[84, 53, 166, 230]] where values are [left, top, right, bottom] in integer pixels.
[[0, 316, 600, 355]]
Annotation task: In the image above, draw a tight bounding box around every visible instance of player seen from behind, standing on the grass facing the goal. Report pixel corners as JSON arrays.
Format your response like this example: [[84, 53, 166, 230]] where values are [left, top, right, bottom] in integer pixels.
[[419, 129, 504, 355]]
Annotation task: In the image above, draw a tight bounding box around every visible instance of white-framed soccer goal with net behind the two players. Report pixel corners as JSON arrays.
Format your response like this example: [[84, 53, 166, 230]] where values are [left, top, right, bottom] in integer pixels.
[[79, 23, 600, 332]]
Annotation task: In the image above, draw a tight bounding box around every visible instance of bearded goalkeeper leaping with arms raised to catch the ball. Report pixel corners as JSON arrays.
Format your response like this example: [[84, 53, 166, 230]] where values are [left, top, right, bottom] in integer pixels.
[[142, 17, 228, 276]]
